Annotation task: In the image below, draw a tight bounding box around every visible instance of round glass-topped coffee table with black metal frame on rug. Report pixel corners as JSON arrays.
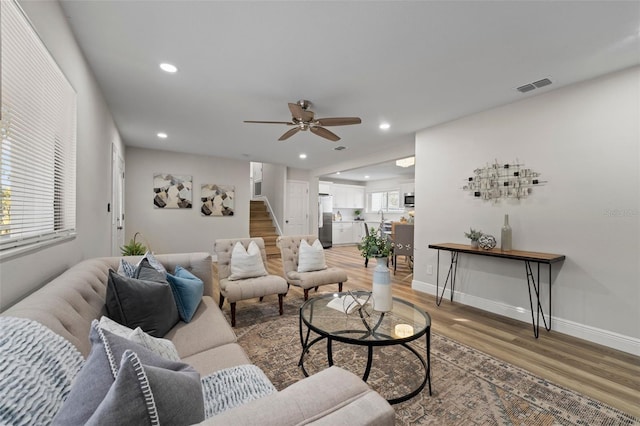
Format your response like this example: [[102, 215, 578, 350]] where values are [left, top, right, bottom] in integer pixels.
[[298, 291, 431, 404]]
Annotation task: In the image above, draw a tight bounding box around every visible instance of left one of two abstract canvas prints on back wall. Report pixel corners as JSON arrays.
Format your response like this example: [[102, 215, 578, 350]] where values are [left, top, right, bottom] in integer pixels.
[[153, 173, 193, 209]]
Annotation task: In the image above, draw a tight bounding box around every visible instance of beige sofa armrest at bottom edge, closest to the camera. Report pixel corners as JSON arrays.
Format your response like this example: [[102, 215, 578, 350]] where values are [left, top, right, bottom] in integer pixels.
[[201, 367, 395, 426]]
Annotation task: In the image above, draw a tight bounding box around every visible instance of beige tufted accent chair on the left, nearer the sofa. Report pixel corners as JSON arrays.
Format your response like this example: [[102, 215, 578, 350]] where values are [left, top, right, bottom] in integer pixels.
[[214, 238, 289, 327]]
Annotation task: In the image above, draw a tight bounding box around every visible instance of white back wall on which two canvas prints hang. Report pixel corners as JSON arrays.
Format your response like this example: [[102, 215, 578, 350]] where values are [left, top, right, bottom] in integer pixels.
[[125, 147, 250, 253]]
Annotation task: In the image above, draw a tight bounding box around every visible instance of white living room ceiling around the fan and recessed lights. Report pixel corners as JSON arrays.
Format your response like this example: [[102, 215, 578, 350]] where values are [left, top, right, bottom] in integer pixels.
[[61, 0, 640, 176]]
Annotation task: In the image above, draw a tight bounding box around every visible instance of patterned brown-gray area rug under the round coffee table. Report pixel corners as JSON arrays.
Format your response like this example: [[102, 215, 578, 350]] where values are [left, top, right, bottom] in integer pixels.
[[228, 298, 640, 425]]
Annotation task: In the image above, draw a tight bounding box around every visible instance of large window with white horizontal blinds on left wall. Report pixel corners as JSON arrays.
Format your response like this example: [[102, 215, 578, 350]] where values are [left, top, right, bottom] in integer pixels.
[[0, 1, 76, 256]]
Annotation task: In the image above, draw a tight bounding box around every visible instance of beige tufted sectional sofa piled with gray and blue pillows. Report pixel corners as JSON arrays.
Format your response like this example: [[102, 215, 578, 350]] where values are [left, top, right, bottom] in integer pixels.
[[0, 253, 395, 425]]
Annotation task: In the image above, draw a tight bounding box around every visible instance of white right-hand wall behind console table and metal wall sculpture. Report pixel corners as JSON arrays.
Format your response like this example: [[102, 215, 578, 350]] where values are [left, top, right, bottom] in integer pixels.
[[414, 68, 640, 354]]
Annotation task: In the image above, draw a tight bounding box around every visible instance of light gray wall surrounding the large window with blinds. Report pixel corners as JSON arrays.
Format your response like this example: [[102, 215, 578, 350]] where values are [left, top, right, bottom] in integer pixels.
[[0, 1, 124, 310]]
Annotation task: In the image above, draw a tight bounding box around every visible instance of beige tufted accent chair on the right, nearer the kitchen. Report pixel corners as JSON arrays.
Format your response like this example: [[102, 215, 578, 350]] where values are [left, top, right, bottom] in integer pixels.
[[276, 235, 347, 300]]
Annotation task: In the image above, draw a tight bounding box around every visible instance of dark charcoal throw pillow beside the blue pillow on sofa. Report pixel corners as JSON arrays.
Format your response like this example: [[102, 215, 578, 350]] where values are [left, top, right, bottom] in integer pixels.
[[105, 270, 180, 337]]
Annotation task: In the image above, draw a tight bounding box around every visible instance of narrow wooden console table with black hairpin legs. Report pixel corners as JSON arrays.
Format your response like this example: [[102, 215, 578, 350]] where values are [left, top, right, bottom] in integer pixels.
[[429, 243, 565, 339]]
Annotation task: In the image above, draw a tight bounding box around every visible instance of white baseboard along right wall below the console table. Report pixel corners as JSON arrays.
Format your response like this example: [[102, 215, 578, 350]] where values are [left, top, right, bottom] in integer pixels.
[[411, 280, 640, 356]]
